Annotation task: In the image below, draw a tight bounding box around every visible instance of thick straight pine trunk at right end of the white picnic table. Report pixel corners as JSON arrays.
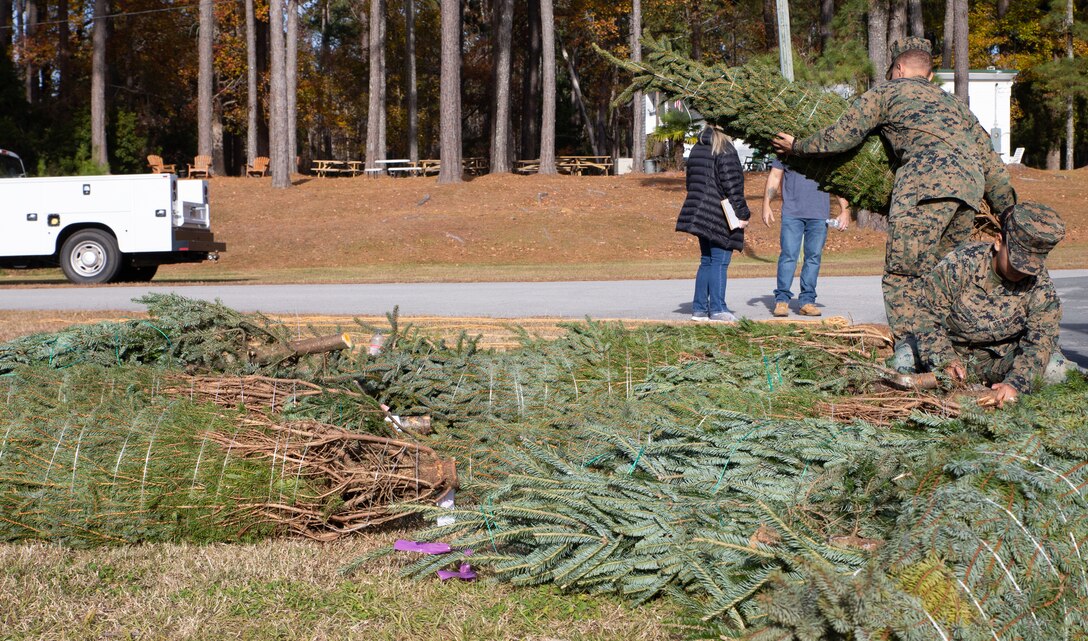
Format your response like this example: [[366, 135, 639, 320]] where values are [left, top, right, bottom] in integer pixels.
[[437, 0, 461, 184]]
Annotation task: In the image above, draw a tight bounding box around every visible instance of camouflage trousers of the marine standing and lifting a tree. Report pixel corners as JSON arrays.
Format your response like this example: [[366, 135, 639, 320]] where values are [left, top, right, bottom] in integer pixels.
[[881, 199, 975, 341]]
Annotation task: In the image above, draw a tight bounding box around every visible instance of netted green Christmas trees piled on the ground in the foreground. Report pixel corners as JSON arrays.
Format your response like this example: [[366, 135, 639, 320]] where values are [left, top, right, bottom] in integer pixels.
[[0, 298, 1088, 640]]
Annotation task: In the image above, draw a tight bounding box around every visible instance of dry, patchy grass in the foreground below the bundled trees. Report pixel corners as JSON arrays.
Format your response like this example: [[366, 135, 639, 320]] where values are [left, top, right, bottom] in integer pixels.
[[0, 533, 678, 641]]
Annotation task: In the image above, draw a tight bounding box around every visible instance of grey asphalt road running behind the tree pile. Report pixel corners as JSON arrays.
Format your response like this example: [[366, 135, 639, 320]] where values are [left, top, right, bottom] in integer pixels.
[[6, 270, 1088, 367]]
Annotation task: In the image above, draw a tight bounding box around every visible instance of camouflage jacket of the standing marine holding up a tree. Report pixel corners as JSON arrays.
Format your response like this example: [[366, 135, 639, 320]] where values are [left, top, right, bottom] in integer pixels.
[[793, 77, 1016, 213]]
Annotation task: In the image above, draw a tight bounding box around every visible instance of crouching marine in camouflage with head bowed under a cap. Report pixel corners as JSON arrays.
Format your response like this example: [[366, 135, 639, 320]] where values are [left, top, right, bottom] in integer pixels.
[[917, 202, 1065, 407]]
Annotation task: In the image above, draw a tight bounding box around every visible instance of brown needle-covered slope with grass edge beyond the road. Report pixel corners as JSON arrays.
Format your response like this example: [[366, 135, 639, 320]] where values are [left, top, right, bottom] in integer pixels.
[[0, 167, 1088, 286]]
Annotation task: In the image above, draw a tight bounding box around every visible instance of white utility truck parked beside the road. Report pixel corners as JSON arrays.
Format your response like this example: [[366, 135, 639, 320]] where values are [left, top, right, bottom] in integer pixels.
[[0, 149, 226, 283]]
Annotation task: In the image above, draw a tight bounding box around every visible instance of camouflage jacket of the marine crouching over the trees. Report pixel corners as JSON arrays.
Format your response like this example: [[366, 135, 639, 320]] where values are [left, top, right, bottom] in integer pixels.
[[918, 243, 1062, 392]]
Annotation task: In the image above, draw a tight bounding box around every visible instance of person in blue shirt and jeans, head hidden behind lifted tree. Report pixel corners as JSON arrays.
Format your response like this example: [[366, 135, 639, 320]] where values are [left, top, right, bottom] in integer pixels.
[[763, 160, 850, 317]]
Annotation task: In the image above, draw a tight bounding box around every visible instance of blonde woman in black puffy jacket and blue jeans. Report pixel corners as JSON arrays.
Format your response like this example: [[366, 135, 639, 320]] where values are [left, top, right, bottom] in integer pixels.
[[677, 125, 752, 321]]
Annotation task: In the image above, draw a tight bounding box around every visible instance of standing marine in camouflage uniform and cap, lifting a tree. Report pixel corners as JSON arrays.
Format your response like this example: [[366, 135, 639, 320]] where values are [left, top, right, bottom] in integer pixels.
[[774, 38, 1016, 363]]
